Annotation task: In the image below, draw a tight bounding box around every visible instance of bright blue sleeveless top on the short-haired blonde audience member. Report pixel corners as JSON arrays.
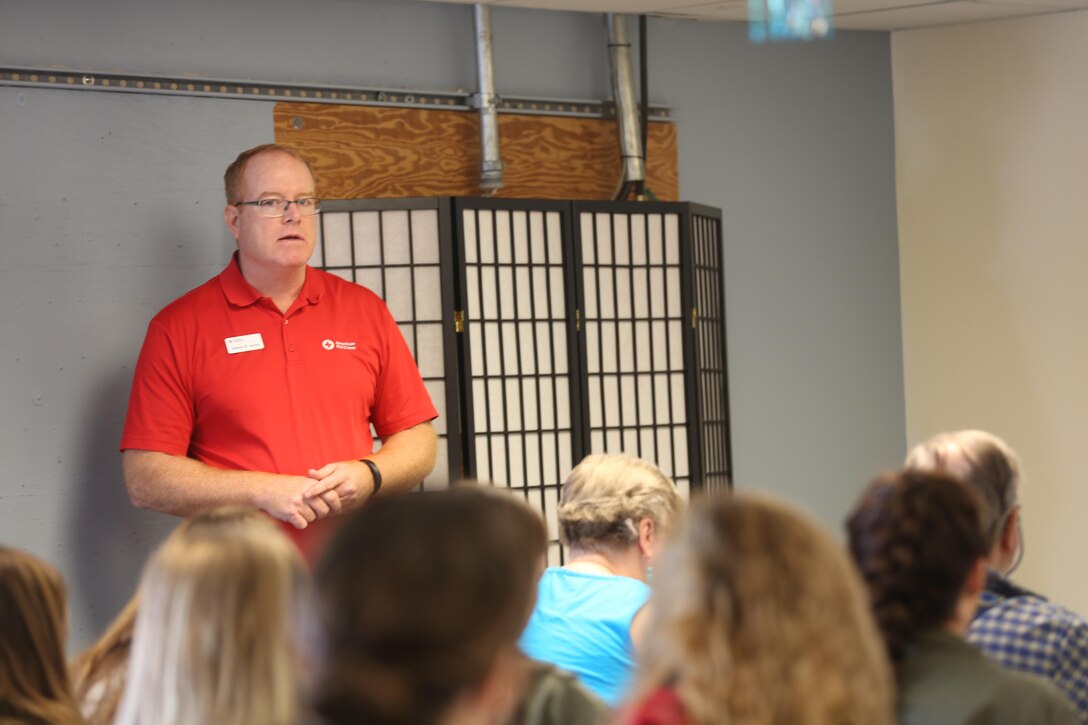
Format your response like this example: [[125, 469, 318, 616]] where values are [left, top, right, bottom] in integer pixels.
[[520, 567, 650, 708]]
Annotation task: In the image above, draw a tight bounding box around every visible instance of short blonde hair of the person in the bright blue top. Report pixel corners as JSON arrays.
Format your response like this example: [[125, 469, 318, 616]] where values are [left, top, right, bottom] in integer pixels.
[[559, 453, 683, 553]]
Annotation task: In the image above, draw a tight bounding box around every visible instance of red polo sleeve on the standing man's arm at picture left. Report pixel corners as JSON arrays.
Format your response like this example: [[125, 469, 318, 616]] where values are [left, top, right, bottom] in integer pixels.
[[121, 320, 195, 456]]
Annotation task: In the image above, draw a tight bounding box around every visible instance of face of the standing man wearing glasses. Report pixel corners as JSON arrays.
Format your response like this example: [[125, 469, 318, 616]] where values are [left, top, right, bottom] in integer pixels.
[[224, 151, 317, 274]]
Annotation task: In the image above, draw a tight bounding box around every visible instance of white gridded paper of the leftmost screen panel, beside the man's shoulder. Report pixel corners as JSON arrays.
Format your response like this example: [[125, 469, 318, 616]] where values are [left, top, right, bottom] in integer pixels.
[[313, 205, 454, 489]]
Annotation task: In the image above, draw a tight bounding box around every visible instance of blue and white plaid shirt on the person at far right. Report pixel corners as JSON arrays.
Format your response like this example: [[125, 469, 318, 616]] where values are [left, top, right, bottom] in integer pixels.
[[967, 572, 1088, 723]]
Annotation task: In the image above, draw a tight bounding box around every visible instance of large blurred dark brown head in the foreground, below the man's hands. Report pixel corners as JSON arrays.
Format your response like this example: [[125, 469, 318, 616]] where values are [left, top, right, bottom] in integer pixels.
[[316, 487, 546, 725]]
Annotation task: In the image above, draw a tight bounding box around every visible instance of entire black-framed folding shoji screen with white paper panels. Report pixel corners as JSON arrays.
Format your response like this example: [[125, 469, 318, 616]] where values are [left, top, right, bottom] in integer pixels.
[[314, 197, 732, 553]]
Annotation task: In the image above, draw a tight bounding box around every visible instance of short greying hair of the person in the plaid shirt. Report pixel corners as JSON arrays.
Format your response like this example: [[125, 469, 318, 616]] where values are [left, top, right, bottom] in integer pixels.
[[904, 430, 1021, 548]]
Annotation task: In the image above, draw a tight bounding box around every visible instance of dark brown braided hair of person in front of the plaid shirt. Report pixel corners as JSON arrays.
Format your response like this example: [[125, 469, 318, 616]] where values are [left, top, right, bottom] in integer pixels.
[[846, 469, 987, 663]]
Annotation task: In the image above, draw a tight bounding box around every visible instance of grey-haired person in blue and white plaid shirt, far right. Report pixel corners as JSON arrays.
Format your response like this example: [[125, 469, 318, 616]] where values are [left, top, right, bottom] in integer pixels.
[[906, 430, 1088, 723]]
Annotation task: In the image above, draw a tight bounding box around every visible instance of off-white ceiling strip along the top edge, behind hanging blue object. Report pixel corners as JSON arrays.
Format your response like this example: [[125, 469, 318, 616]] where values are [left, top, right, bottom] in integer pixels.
[[419, 0, 1088, 30]]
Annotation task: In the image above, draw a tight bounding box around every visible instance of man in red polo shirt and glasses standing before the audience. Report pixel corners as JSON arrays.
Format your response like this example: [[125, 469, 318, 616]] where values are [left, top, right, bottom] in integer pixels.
[[121, 145, 437, 553]]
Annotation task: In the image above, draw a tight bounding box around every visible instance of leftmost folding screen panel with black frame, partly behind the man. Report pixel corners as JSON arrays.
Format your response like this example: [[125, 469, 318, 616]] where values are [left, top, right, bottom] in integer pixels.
[[312, 199, 461, 489]]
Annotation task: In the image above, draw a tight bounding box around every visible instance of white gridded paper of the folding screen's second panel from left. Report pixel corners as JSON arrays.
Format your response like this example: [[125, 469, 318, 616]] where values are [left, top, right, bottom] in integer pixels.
[[460, 208, 577, 563]]
